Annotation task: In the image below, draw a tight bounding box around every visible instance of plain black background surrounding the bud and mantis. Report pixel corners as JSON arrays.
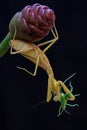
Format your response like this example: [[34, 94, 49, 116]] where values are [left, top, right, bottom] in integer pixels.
[[0, 0, 87, 130]]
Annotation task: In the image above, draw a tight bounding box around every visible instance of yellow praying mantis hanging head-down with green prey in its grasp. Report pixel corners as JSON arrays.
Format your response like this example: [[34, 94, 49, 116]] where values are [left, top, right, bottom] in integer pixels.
[[10, 24, 77, 116]]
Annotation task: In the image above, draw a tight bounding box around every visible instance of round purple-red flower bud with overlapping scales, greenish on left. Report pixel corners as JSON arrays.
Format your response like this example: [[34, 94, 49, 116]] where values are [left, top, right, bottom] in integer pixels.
[[9, 3, 55, 42]]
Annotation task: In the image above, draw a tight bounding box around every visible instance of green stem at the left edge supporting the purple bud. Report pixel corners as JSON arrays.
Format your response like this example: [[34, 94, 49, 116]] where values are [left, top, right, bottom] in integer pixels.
[[0, 33, 11, 57]]
